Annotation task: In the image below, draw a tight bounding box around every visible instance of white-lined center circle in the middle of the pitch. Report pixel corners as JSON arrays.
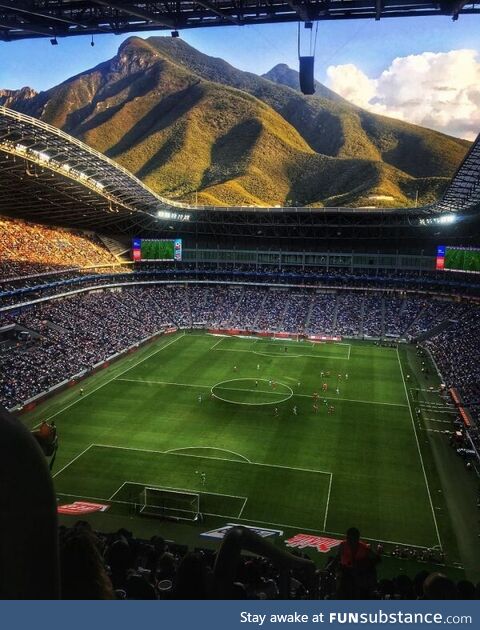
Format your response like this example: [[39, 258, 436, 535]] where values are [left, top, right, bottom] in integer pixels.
[[210, 378, 293, 406]]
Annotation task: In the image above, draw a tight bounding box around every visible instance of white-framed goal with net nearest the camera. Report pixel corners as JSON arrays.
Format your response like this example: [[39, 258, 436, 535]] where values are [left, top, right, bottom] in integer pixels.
[[139, 486, 200, 521]]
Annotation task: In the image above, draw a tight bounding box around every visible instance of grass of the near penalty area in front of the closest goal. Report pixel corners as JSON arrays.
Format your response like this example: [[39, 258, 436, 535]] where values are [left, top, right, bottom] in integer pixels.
[[52, 445, 330, 529]]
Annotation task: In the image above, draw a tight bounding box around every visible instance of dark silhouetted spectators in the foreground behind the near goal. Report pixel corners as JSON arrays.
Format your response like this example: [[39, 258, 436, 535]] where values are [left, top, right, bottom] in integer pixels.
[[53, 521, 480, 600]]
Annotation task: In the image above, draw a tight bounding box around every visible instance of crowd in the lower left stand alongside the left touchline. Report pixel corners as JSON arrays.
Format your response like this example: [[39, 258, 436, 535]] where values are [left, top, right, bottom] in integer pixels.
[[0, 290, 176, 408]]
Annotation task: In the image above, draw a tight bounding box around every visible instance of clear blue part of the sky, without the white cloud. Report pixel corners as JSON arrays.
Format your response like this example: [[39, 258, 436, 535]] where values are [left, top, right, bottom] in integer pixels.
[[0, 16, 480, 90]]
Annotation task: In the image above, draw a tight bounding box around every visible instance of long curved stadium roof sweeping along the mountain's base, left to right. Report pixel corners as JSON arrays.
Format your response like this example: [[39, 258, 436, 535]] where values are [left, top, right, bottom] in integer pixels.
[[0, 106, 480, 239]]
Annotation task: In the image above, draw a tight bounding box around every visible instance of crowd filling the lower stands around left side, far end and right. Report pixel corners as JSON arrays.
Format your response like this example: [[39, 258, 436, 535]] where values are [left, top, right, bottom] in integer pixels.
[[0, 284, 480, 408]]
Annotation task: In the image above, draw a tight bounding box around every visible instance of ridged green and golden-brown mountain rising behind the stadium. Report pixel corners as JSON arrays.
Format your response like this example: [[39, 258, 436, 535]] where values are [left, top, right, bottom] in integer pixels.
[[5, 37, 469, 206]]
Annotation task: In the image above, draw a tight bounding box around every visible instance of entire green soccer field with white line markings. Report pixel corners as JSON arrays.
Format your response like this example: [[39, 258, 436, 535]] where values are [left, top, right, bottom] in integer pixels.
[[24, 333, 460, 547]]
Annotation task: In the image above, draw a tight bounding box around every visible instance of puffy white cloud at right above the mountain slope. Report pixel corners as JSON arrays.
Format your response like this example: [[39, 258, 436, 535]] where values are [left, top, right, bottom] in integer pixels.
[[327, 49, 480, 140]]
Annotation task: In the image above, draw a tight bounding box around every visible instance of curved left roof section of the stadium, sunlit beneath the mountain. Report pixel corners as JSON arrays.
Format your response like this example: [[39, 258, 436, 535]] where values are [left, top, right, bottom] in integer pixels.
[[0, 106, 188, 232]]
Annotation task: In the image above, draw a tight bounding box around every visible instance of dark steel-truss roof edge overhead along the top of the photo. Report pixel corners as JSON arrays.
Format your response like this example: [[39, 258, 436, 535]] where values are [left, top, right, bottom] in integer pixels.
[[0, 0, 480, 41]]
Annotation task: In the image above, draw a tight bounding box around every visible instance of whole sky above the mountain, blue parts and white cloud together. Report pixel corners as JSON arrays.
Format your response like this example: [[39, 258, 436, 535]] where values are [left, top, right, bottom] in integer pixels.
[[0, 16, 480, 140]]
